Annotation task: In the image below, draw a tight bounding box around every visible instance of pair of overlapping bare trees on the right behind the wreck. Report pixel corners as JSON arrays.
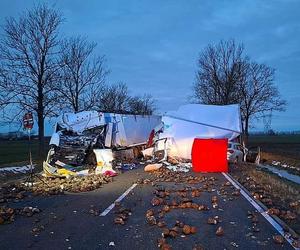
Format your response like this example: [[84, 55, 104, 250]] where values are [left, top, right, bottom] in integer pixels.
[[194, 40, 286, 144]]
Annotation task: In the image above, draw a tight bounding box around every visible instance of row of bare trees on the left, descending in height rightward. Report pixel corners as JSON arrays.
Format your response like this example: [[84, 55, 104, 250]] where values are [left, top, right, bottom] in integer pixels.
[[0, 4, 154, 152]]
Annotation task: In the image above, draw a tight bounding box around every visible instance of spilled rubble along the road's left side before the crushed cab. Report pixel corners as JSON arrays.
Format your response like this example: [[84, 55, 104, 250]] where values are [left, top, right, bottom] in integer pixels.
[[0, 172, 112, 227]]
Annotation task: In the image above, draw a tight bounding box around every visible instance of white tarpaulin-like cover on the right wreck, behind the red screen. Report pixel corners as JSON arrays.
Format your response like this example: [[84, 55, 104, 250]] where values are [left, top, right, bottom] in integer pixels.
[[159, 104, 241, 159]]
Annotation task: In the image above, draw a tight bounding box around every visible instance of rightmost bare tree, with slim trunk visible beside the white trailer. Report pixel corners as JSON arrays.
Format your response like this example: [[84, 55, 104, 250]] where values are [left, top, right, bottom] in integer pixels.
[[239, 62, 286, 141]]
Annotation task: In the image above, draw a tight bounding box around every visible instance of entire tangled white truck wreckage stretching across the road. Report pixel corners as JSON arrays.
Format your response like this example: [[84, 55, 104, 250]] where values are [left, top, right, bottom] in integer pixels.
[[43, 104, 258, 176]]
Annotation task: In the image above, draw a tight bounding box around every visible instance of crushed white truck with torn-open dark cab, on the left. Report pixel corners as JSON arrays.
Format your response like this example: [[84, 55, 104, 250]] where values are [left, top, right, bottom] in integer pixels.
[[43, 111, 161, 177]]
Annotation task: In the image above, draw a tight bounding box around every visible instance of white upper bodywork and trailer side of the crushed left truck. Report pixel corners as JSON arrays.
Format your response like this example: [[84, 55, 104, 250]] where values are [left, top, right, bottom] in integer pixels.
[[50, 111, 161, 148]]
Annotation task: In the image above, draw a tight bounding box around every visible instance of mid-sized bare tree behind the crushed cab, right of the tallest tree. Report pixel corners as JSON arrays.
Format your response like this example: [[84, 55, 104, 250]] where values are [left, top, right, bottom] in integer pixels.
[[59, 37, 108, 112]]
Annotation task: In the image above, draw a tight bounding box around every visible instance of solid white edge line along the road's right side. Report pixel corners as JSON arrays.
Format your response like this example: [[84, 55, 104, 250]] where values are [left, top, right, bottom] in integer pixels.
[[222, 173, 299, 249]]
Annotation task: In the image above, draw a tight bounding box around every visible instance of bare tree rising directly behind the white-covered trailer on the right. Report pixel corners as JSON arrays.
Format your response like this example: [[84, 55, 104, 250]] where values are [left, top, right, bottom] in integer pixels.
[[194, 40, 245, 105]]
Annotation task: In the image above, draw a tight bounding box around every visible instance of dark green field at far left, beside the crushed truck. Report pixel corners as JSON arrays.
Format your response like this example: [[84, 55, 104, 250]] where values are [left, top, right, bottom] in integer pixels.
[[0, 140, 48, 167]]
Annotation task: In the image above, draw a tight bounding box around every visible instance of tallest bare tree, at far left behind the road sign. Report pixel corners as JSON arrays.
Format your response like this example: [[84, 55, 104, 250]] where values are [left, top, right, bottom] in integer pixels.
[[0, 4, 62, 152]]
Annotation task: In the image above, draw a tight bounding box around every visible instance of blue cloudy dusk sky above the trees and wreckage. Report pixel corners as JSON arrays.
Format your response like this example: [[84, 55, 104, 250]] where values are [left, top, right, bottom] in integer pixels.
[[0, 0, 300, 134]]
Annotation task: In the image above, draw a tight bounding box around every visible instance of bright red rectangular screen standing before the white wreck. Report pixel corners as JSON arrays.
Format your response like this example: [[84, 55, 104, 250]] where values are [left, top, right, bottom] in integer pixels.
[[192, 139, 228, 172]]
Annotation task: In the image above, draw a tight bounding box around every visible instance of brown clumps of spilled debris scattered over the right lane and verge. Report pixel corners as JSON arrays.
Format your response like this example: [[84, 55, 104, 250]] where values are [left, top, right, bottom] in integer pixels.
[[140, 167, 294, 249]]
